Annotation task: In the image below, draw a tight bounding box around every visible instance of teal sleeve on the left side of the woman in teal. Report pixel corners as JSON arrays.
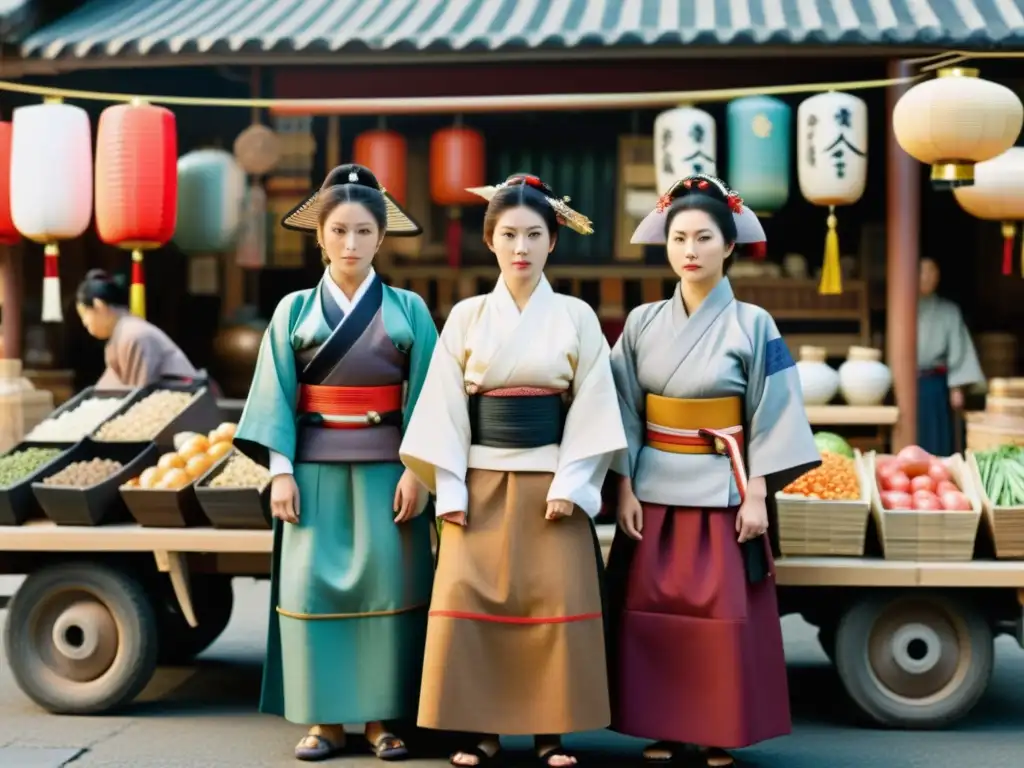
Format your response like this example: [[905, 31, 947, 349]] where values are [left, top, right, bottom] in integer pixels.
[[234, 294, 302, 466]]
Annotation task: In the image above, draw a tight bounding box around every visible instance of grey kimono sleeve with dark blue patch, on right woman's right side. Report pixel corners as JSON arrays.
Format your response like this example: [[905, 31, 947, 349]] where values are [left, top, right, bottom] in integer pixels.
[[741, 305, 821, 493]]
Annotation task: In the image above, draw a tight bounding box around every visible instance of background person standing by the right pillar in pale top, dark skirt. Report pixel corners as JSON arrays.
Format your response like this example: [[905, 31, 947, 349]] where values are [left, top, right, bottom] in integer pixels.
[[918, 258, 985, 456]]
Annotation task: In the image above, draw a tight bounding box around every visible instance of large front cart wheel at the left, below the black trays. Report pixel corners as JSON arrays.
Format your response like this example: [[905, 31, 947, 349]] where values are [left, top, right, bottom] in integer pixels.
[[5, 562, 157, 715]]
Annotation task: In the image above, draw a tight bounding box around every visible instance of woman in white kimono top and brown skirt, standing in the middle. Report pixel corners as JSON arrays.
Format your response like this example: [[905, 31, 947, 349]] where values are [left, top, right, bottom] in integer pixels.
[[400, 175, 626, 768]]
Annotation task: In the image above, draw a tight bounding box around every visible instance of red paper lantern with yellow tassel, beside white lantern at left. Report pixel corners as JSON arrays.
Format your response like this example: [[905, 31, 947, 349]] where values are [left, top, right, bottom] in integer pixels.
[[95, 102, 178, 317]]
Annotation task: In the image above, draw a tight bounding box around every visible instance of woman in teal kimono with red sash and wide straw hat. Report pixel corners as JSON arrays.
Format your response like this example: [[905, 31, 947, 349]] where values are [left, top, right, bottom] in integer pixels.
[[234, 165, 437, 760]]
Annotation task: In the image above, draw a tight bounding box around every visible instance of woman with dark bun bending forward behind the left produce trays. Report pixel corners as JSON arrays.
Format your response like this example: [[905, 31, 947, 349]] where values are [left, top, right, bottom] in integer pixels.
[[76, 269, 202, 389]]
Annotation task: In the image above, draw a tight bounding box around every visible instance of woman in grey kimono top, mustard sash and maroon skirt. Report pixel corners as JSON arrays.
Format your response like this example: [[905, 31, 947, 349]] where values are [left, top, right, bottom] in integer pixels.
[[607, 175, 820, 766]]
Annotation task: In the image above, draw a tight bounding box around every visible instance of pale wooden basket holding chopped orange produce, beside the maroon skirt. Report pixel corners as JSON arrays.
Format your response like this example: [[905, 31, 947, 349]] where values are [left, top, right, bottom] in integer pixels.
[[775, 450, 871, 557]]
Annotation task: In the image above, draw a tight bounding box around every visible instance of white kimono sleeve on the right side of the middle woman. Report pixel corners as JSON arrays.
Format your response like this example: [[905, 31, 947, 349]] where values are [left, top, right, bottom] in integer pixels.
[[548, 302, 627, 517]]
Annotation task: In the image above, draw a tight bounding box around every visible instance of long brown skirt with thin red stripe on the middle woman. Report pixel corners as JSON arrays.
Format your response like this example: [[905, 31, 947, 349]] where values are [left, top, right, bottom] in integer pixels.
[[419, 469, 611, 735]]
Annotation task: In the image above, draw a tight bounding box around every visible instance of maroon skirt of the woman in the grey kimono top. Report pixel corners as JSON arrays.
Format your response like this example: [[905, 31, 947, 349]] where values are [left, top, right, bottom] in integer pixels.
[[607, 504, 792, 749]]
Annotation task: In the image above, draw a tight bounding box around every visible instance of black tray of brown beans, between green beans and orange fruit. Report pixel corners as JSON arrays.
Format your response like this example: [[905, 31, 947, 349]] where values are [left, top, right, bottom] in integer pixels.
[[32, 439, 157, 525]]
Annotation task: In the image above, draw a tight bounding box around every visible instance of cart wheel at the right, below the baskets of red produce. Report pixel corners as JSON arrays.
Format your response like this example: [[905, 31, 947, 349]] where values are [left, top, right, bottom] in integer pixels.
[[836, 591, 994, 728]]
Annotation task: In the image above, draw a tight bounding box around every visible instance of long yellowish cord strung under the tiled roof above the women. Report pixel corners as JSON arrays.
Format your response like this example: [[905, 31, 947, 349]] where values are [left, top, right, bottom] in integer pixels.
[[0, 69, 937, 115]]
